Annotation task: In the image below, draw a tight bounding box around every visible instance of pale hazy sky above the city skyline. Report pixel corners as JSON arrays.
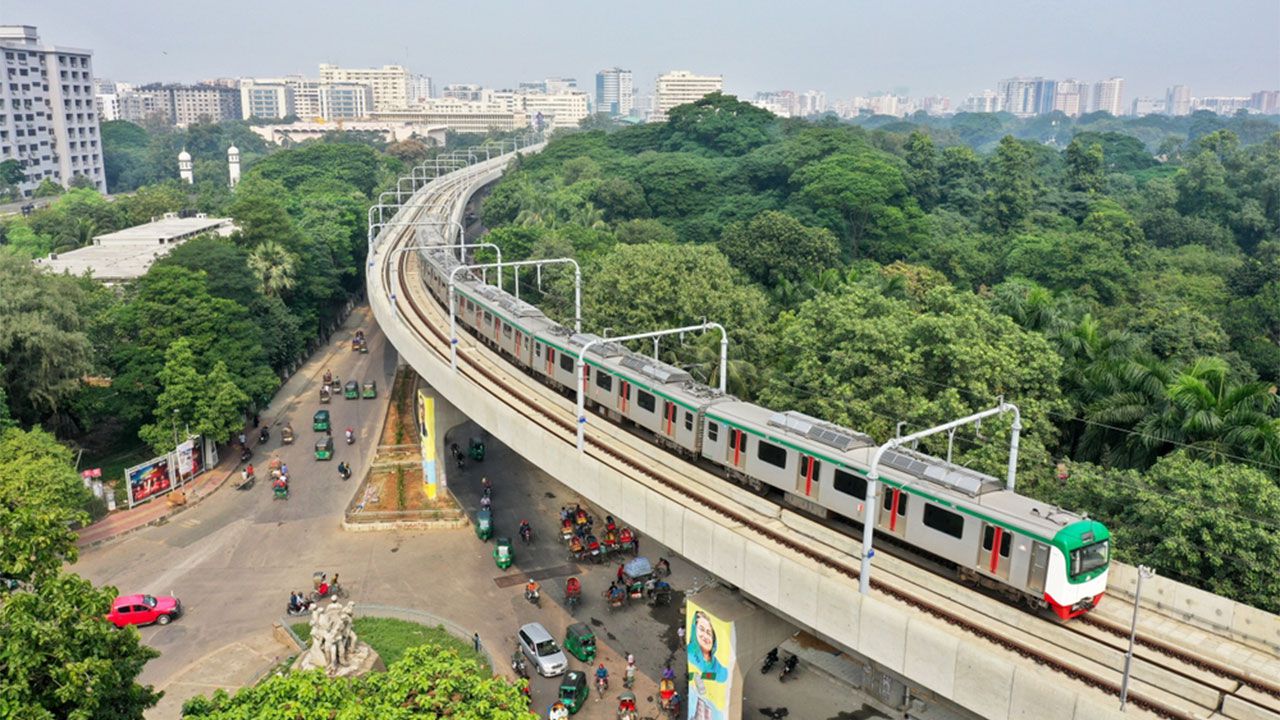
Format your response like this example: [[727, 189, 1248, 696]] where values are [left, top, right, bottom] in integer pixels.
[[10, 0, 1280, 105]]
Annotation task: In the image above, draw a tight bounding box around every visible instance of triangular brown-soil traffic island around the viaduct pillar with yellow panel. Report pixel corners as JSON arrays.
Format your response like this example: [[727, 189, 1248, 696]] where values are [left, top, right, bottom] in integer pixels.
[[342, 366, 467, 532]]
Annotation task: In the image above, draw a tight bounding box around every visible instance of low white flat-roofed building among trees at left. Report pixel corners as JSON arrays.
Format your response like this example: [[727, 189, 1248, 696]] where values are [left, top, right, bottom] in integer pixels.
[[36, 213, 236, 284]]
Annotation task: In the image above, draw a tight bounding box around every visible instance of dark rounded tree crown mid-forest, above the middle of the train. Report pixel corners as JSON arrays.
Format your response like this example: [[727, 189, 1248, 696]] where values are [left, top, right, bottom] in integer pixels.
[[719, 210, 840, 287]]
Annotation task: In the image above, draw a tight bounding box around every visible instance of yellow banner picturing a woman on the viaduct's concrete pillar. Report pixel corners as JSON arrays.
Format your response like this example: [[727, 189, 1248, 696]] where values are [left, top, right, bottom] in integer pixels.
[[685, 600, 736, 720]]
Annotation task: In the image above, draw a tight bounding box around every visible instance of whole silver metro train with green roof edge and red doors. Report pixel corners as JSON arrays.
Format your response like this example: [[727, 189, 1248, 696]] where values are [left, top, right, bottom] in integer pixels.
[[420, 250, 1111, 620]]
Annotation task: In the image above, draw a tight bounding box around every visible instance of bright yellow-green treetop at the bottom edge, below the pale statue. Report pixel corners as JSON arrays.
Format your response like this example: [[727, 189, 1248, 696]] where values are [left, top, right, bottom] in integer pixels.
[[182, 644, 530, 720]]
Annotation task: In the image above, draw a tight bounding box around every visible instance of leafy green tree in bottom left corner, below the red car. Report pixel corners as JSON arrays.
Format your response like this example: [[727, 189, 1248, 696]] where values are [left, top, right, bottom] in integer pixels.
[[0, 573, 161, 720]]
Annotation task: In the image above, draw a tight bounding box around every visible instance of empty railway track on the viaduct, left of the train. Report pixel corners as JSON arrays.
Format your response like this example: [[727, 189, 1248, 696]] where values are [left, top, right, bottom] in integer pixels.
[[380, 158, 1280, 720]]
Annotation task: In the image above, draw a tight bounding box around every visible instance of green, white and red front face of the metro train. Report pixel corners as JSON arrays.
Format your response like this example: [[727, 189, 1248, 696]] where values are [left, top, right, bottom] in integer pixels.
[[1044, 520, 1111, 620]]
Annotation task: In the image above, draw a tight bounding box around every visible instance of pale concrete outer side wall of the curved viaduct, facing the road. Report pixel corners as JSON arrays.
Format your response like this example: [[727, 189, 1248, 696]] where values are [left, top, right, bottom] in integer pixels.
[[369, 161, 1147, 720]]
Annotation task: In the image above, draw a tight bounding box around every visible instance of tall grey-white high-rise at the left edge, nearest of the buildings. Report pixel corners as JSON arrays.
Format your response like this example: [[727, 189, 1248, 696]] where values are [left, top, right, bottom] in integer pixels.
[[0, 26, 106, 196]]
